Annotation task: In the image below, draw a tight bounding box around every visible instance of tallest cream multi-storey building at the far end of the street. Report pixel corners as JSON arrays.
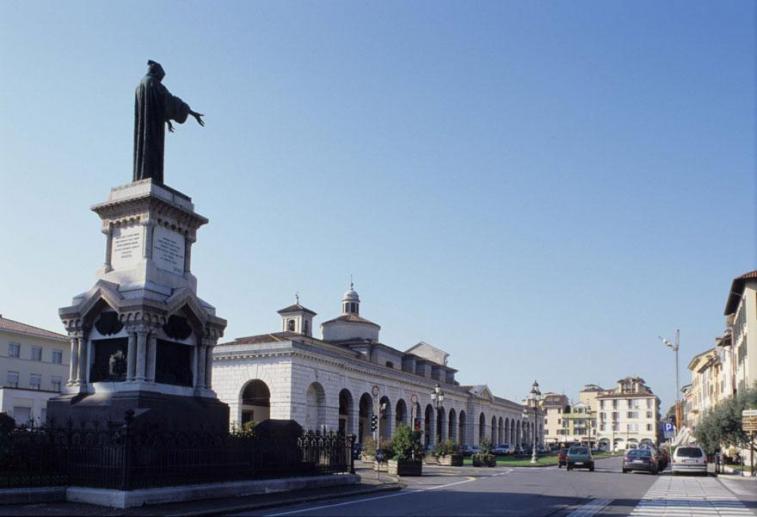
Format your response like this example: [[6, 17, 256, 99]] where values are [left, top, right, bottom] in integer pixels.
[[597, 377, 660, 450]]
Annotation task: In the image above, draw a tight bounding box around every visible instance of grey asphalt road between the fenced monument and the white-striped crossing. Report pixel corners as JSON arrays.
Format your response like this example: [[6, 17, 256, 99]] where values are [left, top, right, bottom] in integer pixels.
[[239, 458, 666, 517]]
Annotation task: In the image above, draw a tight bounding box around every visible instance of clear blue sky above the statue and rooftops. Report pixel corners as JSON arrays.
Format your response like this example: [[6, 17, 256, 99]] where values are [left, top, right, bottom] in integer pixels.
[[0, 0, 757, 412]]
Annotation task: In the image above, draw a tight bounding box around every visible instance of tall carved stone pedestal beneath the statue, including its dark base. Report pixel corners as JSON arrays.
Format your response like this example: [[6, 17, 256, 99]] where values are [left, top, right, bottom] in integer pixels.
[[47, 179, 228, 430]]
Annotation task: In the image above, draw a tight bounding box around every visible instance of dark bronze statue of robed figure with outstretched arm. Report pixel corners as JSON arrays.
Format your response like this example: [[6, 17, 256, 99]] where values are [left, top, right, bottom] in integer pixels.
[[134, 61, 205, 185]]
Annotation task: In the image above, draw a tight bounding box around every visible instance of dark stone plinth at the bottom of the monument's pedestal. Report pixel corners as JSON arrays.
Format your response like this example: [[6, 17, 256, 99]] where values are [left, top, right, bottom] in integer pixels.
[[47, 391, 229, 433]]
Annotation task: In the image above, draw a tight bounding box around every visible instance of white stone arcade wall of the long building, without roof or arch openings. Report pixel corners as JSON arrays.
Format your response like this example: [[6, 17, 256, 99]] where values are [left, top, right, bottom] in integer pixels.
[[213, 342, 532, 445]]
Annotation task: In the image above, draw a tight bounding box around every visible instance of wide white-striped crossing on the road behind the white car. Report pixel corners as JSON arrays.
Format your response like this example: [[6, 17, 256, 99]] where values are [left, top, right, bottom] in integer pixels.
[[631, 476, 755, 517]]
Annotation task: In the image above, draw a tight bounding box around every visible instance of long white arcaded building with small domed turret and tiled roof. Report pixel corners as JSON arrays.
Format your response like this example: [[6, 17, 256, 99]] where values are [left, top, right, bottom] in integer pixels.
[[213, 288, 543, 446]]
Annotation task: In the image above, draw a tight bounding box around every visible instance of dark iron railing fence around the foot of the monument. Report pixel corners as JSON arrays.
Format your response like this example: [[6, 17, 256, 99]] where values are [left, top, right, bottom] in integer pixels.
[[0, 423, 354, 490]]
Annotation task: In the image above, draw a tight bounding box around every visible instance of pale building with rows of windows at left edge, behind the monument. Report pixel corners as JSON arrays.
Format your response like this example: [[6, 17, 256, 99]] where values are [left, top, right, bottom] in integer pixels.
[[0, 315, 70, 425]]
